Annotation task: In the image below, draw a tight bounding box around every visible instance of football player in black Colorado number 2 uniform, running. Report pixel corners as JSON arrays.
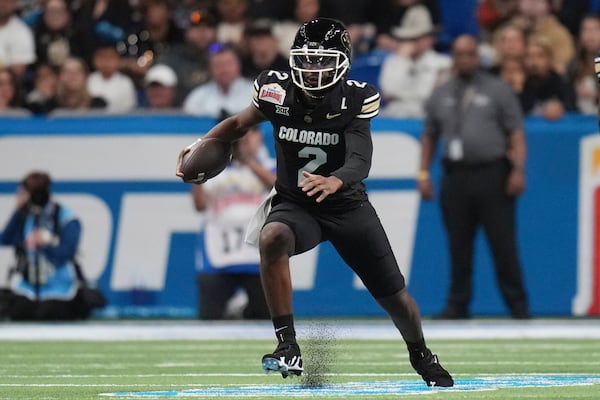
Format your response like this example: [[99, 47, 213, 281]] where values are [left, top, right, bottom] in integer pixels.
[[177, 18, 454, 387]]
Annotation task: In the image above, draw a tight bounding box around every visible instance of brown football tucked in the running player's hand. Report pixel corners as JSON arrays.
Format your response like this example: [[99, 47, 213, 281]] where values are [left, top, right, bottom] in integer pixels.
[[181, 138, 232, 183]]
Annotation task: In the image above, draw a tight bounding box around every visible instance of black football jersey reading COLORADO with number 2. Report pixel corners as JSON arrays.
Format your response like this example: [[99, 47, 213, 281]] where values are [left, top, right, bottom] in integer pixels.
[[252, 71, 380, 210]]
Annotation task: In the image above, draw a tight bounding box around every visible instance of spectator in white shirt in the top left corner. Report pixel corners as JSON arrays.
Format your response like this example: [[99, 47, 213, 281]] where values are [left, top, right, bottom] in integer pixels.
[[0, 0, 36, 79]]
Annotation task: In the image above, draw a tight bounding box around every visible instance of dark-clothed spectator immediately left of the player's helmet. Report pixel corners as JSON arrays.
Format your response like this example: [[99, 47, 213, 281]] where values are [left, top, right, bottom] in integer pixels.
[[242, 20, 290, 79]]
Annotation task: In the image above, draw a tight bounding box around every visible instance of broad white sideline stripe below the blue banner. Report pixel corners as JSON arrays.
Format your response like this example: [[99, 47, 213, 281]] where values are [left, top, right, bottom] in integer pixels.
[[0, 318, 600, 340]]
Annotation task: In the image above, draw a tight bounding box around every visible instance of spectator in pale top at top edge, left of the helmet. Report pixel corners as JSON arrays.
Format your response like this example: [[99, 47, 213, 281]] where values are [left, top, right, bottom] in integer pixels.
[[216, 0, 249, 51]]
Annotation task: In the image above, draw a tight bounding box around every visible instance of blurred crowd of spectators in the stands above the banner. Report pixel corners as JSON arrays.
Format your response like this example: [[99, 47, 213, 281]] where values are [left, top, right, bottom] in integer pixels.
[[0, 0, 600, 120]]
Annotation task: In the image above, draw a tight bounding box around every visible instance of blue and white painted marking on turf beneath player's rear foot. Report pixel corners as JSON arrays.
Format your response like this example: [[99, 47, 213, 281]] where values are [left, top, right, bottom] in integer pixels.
[[101, 375, 600, 399]]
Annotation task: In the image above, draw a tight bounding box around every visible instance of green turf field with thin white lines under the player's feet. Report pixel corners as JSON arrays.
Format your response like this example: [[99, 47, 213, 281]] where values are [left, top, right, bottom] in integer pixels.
[[0, 338, 600, 400]]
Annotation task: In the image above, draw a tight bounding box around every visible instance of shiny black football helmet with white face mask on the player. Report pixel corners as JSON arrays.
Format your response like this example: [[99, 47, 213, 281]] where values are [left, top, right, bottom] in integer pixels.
[[290, 18, 352, 92]]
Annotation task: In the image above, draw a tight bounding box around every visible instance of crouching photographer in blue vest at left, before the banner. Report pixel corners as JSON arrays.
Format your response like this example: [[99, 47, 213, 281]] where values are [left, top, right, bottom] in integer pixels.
[[0, 171, 102, 320]]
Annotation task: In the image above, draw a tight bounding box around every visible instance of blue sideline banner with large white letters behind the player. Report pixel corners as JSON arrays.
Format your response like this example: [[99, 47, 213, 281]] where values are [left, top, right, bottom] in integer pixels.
[[0, 116, 600, 317]]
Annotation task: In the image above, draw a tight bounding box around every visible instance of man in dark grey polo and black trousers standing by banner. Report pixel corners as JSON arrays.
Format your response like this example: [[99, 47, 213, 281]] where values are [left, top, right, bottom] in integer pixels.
[[417, 35, 529, 319]]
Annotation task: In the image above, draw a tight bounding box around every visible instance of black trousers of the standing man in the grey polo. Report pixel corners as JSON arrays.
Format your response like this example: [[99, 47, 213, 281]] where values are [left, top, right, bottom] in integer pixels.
[[441, 160, 528, 315]]
